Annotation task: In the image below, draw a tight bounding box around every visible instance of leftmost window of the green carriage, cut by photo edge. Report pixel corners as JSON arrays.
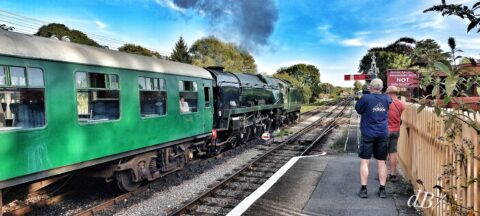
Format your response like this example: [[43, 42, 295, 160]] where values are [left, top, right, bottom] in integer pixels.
[[0, 66, 46, 131]]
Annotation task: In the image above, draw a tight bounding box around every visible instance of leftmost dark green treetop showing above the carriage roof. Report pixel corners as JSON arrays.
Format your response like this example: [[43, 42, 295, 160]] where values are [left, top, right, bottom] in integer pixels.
[[35, 23, 100, 47]]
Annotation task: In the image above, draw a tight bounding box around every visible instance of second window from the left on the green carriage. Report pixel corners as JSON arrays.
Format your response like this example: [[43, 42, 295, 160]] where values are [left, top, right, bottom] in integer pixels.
[[75, 72, 120, 123]]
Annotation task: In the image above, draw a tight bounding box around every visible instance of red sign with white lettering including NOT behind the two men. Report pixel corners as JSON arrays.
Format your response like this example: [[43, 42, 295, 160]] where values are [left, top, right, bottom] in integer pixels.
[[387, 70, 418, 90]]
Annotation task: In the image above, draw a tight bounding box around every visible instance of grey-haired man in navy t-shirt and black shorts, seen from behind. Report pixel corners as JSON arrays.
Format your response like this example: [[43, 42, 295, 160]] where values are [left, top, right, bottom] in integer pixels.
[[355, 79, 392, 198]]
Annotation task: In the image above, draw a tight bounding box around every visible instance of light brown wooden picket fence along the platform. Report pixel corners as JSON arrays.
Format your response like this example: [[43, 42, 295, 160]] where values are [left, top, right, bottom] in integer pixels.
[[398, 105, 480, 216]]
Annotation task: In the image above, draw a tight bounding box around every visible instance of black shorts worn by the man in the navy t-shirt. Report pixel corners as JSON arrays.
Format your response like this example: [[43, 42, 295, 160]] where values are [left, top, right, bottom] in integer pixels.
[[358, 136, 388, 160]]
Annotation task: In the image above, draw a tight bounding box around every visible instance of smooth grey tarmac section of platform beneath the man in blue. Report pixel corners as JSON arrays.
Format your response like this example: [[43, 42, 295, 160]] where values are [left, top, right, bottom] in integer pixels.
[[304, 155, 399, 215]]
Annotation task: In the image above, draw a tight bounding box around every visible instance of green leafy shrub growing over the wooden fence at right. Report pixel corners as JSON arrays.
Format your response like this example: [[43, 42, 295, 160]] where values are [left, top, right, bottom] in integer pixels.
[[417, 38, 480, 215]]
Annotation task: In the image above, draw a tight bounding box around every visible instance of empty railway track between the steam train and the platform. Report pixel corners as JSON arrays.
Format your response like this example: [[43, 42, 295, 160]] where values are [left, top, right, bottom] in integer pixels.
[[169, 100, 351, 215]]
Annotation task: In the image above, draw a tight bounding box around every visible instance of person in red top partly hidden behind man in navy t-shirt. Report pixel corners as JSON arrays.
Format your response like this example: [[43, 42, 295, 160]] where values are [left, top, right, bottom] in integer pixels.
[[387, 86, 405, 182]]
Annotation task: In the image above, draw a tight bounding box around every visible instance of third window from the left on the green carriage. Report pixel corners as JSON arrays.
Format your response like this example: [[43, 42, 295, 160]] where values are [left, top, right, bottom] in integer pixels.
[[138, 77, 167, 117]]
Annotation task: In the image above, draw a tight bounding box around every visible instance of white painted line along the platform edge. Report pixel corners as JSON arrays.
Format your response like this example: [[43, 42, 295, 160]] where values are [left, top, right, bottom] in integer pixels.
[[227, 157, 302, 216]]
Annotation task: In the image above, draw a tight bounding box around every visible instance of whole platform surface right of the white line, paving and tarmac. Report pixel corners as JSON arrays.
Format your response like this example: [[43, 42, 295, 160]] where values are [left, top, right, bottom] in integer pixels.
[[230, 154, 416, 215]]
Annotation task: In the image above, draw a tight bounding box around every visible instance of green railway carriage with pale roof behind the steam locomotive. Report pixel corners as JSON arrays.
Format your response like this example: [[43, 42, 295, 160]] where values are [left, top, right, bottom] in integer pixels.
[[0, 31, 213, 191]]
